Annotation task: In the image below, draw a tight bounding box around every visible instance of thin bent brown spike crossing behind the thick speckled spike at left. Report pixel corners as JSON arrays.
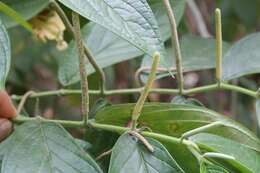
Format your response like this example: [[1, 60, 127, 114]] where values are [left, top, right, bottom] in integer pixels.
[[50, 0, 106, 93]]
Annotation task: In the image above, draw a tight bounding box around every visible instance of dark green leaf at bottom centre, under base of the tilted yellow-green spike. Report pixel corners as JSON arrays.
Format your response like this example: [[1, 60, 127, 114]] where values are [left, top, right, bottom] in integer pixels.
[[108, 133, 184, 173]]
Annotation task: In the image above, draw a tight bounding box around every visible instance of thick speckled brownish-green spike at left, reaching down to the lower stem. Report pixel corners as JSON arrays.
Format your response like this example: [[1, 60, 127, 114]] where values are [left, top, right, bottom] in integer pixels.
[[72, 12, 89, 125]]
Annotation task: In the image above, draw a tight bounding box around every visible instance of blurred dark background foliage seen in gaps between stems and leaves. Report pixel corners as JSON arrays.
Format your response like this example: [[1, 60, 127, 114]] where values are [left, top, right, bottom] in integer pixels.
[[2, 0, 260, 139]]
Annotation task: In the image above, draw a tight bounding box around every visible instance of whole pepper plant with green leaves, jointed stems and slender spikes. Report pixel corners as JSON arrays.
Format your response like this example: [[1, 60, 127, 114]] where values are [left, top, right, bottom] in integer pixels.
[[0, 0, 260, 173]]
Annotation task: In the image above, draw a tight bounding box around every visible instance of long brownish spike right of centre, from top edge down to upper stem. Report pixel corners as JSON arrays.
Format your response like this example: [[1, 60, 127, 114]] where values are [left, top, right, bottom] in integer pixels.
[[163, 0, 184, 95]]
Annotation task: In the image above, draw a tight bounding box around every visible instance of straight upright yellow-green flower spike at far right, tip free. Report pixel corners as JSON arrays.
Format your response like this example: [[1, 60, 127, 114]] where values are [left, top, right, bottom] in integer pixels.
[[215, 9, 222, 84]]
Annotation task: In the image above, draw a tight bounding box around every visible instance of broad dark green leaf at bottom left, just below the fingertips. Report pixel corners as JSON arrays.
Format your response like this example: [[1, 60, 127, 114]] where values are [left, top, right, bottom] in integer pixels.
[[2, 120, 102, 173]]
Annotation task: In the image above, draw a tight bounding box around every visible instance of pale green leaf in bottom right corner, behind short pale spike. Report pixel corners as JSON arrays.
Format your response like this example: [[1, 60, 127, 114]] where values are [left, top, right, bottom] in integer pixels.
[[190, 133, 260, 173]]
